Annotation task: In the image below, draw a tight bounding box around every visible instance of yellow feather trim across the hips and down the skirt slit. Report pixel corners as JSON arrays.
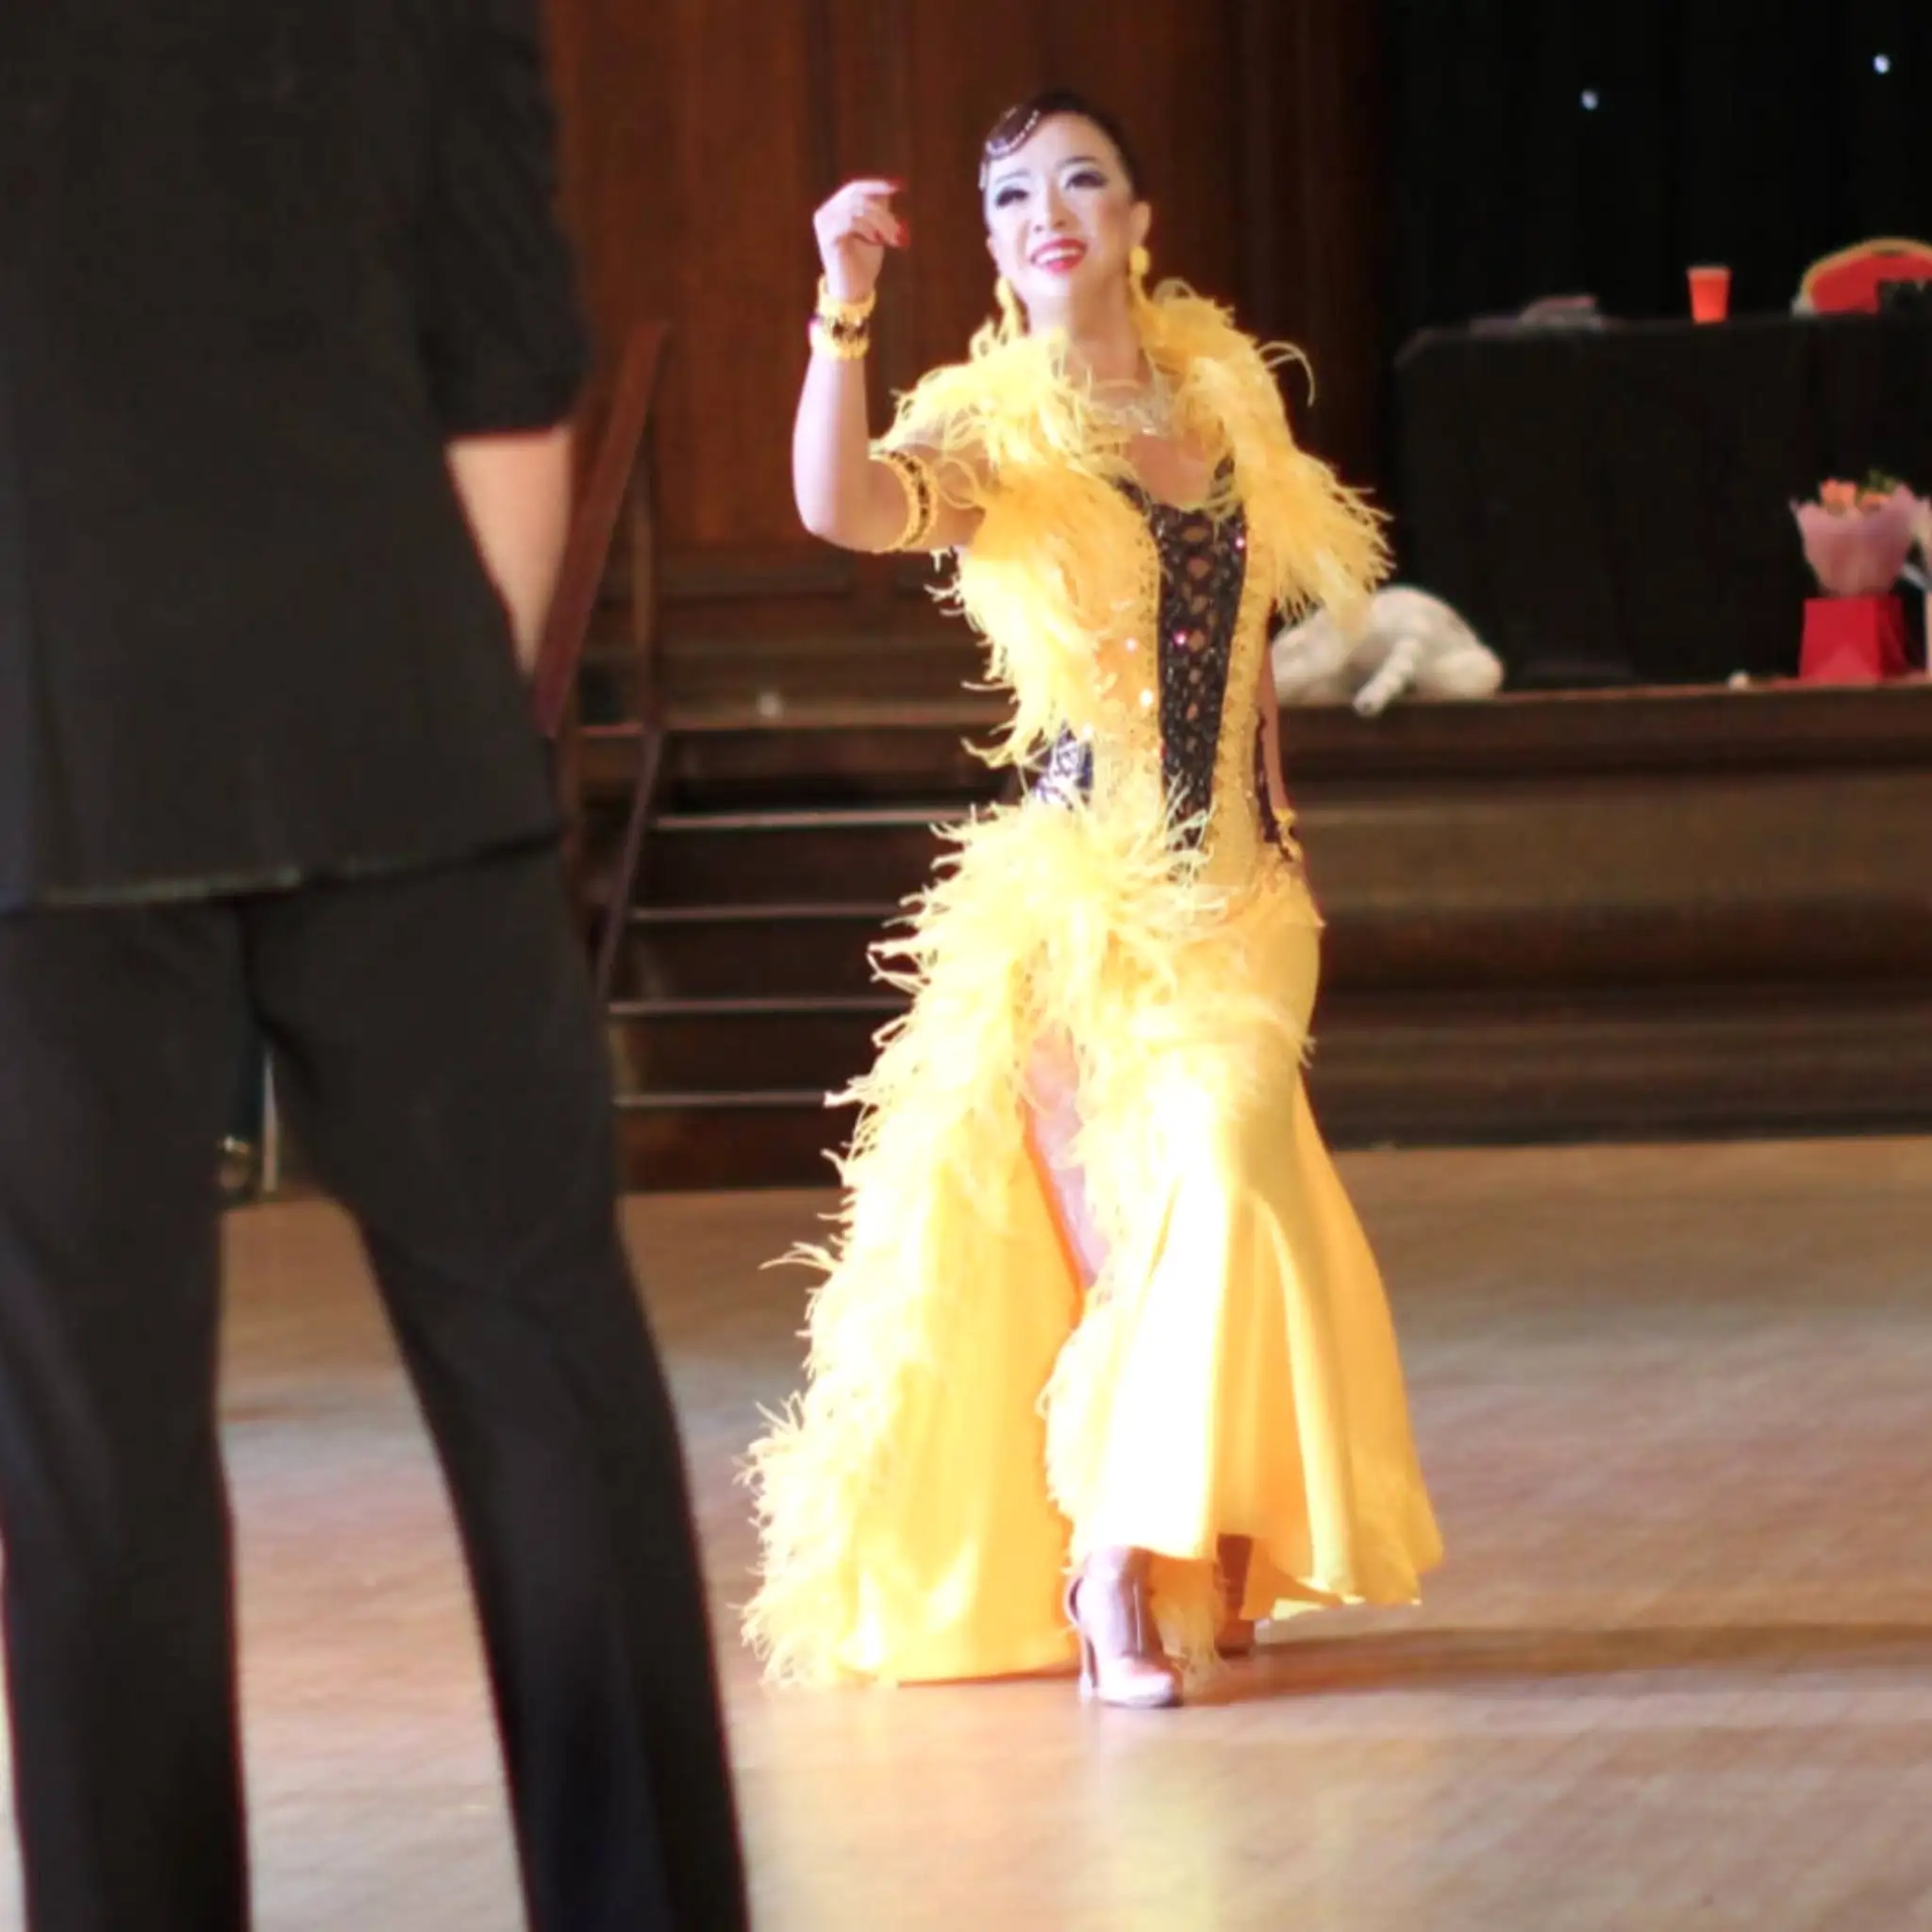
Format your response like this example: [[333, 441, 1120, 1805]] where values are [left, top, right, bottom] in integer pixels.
[[743, 804, 1318, 1683]]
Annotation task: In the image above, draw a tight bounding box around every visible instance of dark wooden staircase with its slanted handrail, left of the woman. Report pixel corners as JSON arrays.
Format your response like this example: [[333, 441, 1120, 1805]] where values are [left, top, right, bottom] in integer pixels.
[[535, 325, 997, 1191]]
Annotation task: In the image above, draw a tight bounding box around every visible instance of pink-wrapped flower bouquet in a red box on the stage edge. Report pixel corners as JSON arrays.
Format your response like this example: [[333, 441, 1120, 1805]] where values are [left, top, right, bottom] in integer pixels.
[[1790, 475, 1926, 684]]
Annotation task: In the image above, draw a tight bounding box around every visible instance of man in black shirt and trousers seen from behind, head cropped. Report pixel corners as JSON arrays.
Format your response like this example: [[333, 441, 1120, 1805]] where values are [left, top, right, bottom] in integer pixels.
[[0, 0, 743, 1932]]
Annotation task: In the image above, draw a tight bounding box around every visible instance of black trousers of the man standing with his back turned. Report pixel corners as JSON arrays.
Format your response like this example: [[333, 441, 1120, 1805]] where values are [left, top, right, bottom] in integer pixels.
[[0, 850, 746, 1932]]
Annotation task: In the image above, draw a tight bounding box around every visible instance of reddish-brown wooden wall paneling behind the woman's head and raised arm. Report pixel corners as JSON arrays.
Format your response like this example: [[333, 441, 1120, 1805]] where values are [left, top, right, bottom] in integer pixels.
[[549, 0, 1379, 697]]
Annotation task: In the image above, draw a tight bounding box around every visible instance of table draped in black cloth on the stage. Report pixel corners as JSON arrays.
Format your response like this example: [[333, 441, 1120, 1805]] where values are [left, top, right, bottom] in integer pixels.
[[1397, 315, 1932, 688]]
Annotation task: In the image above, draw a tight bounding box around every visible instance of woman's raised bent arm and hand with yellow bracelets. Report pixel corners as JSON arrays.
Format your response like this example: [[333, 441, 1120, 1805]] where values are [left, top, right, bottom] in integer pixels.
[[792, 182, 979, 551]]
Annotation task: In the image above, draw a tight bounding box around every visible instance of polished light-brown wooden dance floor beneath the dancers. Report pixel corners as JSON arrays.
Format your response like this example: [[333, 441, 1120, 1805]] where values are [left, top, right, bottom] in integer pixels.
[[0, 1141, 1932, 1932]]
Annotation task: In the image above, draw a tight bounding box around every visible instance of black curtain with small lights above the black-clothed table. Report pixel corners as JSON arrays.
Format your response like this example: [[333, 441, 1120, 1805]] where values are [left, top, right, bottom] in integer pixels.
[[1383, 0, 1932, 332]]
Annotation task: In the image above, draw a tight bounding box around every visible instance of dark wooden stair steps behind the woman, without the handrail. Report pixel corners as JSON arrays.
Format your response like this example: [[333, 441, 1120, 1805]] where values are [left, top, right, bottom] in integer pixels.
[[586, 701, 999, 1191]]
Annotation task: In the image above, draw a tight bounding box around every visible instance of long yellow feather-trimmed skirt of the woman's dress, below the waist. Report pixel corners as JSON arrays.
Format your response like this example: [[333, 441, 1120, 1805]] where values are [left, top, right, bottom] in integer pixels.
[[746, 806, 1440, 1683]]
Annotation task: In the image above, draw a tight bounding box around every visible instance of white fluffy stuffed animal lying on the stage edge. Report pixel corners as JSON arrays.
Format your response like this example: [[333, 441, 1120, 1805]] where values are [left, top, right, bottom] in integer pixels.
[[1275, 583, 1503, 719]]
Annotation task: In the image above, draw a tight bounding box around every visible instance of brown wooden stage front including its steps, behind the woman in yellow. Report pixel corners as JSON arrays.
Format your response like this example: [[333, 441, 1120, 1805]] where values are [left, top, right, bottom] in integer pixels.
[[586, 680, 1932, 1191]]
